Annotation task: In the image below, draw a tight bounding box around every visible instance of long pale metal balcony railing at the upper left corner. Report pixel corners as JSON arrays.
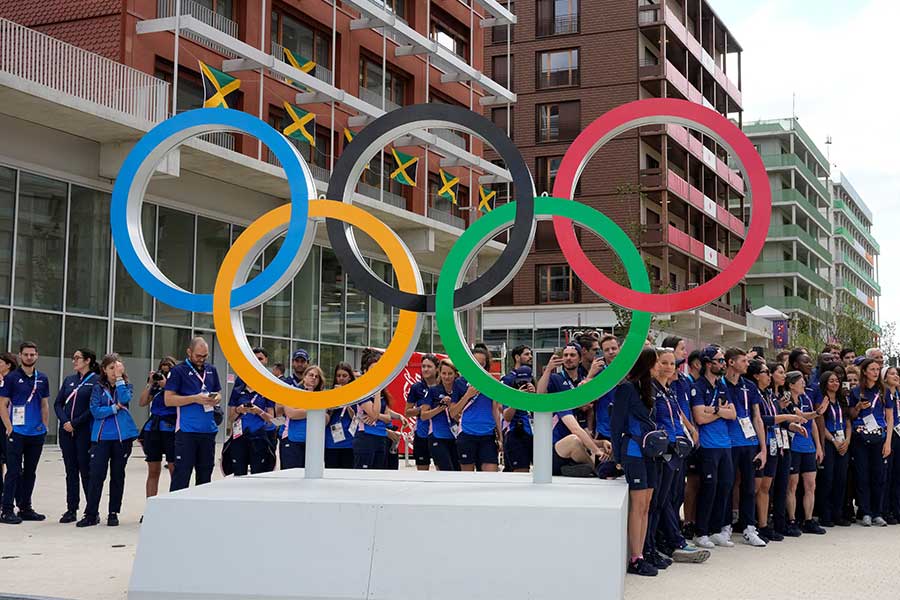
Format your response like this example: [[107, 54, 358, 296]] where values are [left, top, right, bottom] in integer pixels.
[[0, 18, 170, 123]]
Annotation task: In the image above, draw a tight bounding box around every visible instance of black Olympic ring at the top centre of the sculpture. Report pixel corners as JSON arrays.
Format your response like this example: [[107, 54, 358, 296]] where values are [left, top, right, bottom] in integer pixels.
[[326, 104, 536, 313]]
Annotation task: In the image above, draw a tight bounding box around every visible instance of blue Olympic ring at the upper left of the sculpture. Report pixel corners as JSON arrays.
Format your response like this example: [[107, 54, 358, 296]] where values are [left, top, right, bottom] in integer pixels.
[[110, 108, 316, 313]]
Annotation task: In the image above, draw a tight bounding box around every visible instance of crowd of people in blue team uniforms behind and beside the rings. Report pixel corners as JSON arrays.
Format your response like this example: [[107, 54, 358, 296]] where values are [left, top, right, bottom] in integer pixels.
[[0, 332, 900, 576]]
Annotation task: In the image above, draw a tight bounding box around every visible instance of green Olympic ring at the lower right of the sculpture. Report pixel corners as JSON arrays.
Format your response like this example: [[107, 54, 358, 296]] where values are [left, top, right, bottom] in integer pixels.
[[434, 196, 651, 412]]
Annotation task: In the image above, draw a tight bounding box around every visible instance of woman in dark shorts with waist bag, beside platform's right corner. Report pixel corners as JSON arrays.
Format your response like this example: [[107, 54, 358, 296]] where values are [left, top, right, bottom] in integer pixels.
[[610, 348, 659, 577]]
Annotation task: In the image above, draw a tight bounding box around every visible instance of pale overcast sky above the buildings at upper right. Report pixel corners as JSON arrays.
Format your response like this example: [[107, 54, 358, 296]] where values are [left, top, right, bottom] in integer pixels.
[[709, 0, 900, 326]]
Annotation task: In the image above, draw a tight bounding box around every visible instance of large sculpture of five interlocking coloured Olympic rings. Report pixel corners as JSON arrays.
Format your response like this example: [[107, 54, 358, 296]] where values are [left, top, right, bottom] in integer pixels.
[[110, 99, 772, 412]]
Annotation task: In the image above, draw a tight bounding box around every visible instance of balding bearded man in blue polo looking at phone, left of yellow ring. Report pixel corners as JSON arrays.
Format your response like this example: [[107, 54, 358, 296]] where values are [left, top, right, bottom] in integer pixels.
[[164, 337, 222, 492]]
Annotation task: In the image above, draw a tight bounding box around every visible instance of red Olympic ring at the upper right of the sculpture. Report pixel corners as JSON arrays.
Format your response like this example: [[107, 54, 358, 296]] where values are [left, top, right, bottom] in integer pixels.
[[553, 98, 772, 313]]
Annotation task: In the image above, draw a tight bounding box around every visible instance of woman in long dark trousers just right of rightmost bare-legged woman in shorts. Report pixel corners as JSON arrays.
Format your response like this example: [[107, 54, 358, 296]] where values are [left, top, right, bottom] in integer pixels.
[[816, 369, 853, 527]]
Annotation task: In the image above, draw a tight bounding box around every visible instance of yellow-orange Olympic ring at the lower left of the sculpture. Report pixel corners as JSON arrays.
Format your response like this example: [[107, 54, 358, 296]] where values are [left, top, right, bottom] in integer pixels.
[[213, 200, 424, 410]]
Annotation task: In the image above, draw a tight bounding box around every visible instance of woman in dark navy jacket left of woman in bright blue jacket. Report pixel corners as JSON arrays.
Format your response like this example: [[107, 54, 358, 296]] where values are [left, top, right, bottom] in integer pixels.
[[53, 348, 100, 523]]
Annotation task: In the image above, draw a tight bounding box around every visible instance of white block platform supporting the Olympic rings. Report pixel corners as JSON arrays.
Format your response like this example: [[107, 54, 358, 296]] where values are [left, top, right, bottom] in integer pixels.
[[128, 469, 628, 600]]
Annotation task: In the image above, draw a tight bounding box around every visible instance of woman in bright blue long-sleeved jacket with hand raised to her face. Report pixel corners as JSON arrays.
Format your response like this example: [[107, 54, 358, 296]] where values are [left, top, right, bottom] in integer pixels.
[[75, 354, 138, 527]]
